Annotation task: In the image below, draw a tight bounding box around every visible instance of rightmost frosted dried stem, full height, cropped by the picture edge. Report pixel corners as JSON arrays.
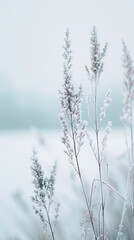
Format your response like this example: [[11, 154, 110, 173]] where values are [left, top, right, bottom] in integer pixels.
[[122, 42, 134, 239]]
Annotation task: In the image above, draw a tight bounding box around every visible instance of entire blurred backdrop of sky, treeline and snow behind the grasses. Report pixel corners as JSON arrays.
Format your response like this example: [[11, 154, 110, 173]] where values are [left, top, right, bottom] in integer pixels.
[[0, 0, 134, 240]]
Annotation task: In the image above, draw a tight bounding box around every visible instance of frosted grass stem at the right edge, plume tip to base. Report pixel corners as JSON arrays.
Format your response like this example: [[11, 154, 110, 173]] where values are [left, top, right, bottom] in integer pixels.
[[118, 41, 134, 239]]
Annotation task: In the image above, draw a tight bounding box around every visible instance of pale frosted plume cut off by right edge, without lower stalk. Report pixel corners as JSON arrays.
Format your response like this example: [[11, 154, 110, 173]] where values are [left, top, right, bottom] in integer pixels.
[[121, 42, 134, 166]]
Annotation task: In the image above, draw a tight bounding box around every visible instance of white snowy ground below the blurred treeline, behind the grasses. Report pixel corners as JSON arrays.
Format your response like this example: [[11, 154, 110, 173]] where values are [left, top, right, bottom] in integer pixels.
[[0, 130, 128, 240]]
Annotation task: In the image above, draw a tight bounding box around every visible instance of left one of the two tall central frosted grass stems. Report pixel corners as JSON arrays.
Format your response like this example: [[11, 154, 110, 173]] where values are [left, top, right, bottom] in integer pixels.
[[59, 29, 97, 240]]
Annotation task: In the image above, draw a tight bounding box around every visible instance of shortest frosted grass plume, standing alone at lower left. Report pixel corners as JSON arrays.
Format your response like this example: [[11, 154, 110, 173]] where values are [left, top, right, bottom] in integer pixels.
[[31, 149, 60, 240]]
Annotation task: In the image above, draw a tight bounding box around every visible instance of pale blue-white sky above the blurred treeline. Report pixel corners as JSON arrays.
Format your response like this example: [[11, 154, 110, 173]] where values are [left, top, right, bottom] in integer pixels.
[[0, 0, 134, 95]]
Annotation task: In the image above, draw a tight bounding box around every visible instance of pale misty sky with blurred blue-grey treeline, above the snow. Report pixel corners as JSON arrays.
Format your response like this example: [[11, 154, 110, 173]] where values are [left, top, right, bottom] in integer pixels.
[[0, 0, 134, 129]]
